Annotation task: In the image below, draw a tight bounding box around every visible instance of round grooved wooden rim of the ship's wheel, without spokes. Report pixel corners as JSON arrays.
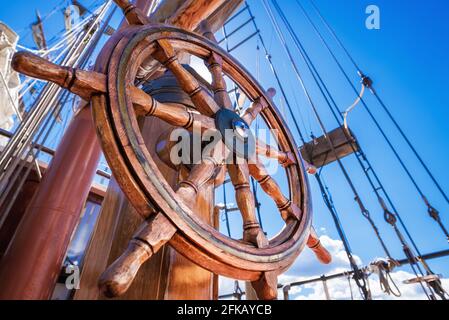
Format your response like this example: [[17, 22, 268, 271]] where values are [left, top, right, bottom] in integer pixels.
[[92, 24, 312, 280]]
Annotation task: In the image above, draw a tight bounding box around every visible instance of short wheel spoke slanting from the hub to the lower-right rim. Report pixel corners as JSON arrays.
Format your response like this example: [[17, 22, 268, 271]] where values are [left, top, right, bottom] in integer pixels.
[[248, 161, 301, 222]]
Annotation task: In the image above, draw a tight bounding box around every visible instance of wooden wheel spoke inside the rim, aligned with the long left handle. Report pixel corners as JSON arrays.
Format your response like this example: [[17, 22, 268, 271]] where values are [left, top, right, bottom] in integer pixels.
[[128, 86, 216, 131]]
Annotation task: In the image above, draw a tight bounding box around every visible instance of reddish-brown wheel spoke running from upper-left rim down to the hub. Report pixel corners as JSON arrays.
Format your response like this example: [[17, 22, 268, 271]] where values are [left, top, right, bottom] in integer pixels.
[[153, 39, 219, 116]]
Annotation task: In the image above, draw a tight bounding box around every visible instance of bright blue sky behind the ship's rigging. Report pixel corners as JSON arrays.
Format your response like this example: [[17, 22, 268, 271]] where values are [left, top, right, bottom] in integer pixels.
[[0, 0, 449, 300]]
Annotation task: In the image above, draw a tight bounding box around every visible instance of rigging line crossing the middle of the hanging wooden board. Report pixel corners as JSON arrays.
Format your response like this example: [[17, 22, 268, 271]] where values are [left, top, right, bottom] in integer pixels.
[[263, 0, 391, 258]]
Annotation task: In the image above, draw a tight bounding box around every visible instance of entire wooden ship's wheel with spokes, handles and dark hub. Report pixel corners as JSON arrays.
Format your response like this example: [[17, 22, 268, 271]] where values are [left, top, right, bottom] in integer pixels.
[[13, 1, 330, 299]]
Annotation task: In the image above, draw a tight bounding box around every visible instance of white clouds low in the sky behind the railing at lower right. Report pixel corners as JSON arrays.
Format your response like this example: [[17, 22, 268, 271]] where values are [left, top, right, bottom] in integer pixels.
[[220, 235, 449, 300]]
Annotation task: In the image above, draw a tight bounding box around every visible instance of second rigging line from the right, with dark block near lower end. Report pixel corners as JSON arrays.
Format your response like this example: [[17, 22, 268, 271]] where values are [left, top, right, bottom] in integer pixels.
[[296, 1, 449, 239]]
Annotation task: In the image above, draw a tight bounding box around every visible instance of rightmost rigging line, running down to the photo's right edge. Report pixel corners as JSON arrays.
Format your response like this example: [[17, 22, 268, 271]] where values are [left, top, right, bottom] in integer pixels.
[[308, 0, 449, 203]]
